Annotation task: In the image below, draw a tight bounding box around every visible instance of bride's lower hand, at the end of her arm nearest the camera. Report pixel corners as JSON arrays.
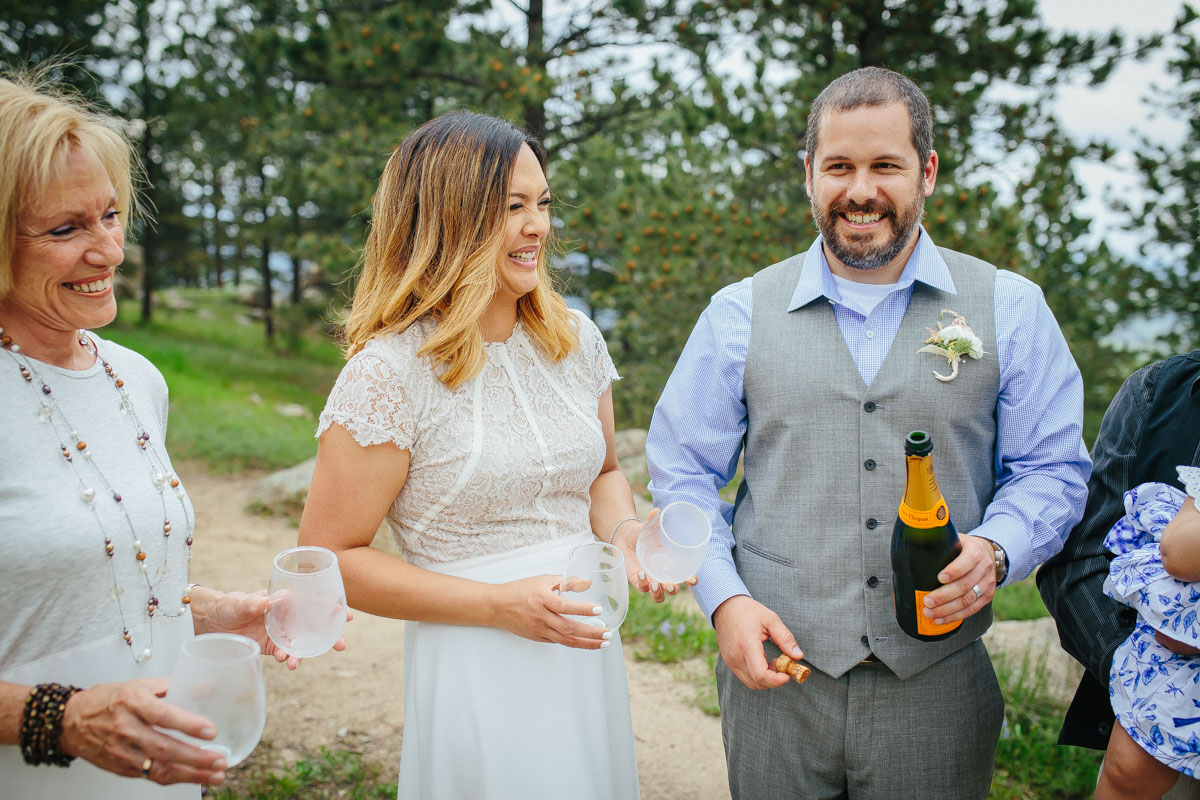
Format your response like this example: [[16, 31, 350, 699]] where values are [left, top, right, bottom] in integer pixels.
[[493, 575, 612, 650]]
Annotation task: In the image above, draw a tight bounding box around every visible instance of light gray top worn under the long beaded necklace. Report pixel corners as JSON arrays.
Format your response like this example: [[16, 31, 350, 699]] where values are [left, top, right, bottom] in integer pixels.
[[0, 333, 194, 685]]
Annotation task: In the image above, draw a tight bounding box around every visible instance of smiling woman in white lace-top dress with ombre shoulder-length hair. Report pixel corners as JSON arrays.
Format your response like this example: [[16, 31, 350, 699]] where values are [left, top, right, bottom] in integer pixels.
[[300, 113, 674, 800]]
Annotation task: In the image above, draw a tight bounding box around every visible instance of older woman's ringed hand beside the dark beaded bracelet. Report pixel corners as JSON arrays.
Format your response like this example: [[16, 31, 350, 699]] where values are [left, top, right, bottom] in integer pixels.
[[60, 678, 226, 784]]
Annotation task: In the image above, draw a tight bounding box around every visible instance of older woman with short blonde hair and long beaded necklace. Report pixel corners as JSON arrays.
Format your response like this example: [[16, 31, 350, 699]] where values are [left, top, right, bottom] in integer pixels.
[[0, 67, 344, 800]]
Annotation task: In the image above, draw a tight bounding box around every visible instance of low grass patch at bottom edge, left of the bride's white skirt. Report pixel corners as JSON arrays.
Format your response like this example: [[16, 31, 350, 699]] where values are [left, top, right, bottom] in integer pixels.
[[205, 747, 396, 800]]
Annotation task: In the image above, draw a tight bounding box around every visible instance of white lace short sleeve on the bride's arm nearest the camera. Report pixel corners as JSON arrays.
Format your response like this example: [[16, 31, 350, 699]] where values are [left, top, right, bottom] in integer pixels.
[[317, 353, 415, 450]]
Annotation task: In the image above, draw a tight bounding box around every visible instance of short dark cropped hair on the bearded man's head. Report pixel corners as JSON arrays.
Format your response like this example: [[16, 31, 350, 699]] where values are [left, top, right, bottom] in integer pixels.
[[804, 67, 934, 166]]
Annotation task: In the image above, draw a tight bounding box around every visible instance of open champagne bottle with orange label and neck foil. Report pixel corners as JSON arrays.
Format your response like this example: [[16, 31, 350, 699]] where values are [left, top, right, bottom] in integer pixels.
[[892, 431, 962, 642]]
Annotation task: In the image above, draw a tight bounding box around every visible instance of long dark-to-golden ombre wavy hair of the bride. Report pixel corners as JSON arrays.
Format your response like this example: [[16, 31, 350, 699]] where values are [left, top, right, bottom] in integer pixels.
[[344, 112, 578, 389]]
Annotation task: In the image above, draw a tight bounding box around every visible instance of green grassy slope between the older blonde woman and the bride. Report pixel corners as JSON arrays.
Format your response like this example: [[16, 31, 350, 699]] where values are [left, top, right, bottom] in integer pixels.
[[101, 289, 343, 473]]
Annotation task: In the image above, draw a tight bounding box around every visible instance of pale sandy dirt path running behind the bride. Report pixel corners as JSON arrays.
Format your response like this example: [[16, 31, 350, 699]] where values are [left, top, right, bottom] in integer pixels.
[[180, 464, 730, 800]]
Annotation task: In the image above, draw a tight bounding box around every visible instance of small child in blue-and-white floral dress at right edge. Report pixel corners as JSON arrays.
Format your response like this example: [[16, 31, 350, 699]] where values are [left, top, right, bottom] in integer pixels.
[[1096, 467, 1200, 800]]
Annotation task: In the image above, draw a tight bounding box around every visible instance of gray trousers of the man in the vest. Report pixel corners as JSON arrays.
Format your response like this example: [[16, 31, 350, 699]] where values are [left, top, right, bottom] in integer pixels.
[[716, 640, 1004, 800]]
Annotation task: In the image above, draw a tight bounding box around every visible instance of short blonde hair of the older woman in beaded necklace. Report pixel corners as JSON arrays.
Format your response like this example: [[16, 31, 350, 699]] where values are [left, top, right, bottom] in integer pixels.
[[0, 65, 137, 300]]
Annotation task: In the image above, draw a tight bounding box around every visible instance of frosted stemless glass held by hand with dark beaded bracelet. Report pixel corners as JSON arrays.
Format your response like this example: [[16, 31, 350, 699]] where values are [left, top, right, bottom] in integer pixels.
[[167, 633, 266, 766]]
